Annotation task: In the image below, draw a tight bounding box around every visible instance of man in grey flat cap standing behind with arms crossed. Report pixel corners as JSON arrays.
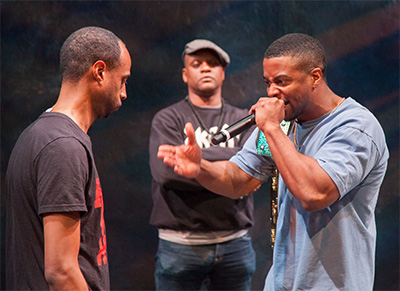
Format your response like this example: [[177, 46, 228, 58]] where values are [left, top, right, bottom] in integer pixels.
[[150, 39, 255, 290]]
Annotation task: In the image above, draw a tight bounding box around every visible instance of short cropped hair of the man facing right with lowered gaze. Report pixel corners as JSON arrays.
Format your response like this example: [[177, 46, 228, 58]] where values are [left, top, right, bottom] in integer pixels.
[[60, 26, 122, 82]]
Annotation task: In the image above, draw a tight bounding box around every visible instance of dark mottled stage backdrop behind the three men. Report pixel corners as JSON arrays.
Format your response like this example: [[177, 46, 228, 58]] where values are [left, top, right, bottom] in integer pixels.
[[0, 1, 400, 290]]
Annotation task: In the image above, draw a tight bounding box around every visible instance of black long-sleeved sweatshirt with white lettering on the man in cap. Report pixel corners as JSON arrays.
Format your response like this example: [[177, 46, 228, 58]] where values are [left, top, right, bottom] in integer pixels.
[[149, 100, 253, 232]]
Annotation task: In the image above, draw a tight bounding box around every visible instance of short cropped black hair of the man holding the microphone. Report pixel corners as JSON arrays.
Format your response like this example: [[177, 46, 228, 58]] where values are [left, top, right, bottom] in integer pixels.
[[264, 33, 326, 81]]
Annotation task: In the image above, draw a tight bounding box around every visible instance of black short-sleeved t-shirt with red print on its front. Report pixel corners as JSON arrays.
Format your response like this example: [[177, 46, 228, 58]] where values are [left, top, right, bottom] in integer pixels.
[[6, 112, 110, 290]]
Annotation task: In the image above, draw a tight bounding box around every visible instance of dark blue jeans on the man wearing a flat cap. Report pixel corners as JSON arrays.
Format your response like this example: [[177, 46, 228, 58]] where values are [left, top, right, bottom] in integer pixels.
[[155, 235, 256, 290]]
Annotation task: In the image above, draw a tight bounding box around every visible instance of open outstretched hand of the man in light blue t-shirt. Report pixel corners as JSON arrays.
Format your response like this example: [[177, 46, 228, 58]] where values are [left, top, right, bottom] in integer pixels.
[[157, 123, 201, 178]]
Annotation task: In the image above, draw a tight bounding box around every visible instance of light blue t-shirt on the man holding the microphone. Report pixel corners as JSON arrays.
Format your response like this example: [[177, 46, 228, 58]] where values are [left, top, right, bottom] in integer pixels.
[[231, 97, 389, 291]]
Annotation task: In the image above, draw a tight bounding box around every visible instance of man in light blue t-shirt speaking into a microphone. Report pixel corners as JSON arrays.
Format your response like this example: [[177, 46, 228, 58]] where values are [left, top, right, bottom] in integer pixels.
[[158, 33, 389, 291]]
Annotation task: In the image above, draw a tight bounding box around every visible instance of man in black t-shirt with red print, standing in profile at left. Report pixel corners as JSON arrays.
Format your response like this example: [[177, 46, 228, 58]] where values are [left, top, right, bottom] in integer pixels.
[[6, 27, 131, 290]]
